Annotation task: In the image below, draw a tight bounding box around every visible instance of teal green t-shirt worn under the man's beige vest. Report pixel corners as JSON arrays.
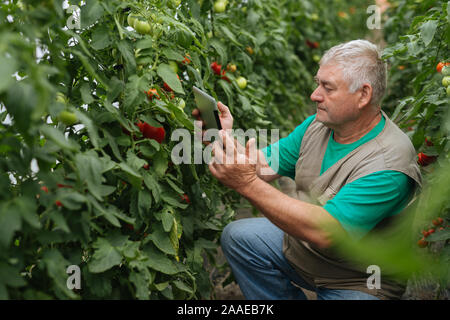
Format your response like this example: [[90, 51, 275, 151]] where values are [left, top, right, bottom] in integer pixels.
[[262, 115, 414, 239]]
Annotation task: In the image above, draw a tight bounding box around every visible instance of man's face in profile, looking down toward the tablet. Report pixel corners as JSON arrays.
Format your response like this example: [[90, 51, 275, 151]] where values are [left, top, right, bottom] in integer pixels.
[[311, 64, 360, 128]]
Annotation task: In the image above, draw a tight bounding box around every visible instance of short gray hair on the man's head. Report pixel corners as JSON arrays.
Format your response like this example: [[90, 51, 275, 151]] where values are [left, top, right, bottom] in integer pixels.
[[319, 39, 387, 107]]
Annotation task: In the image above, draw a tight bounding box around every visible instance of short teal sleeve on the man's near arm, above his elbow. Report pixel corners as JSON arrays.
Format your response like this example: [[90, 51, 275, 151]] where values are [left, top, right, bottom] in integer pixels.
[[324, 170, 415, 239]]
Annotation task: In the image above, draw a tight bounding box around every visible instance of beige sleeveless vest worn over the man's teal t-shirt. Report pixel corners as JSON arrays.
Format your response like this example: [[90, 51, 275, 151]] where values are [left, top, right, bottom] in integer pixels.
[[283, 111, 421, 299]]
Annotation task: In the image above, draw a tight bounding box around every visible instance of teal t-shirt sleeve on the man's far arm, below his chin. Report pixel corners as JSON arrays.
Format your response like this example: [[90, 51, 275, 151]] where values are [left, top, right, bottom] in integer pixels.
[[261, 114, 316, 179]]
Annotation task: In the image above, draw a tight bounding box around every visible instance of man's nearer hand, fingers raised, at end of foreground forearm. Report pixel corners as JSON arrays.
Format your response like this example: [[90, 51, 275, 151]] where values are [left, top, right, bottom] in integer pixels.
[[209, 130, 258, 193]]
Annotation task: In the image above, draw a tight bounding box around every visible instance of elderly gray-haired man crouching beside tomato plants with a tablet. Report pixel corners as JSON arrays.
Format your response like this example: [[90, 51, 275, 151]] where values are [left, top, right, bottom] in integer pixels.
[[197, 40, 421, 299]]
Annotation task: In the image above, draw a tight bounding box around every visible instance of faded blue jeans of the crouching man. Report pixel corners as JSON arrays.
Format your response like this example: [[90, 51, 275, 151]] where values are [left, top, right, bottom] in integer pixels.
[[220, 218, 378, 300]]
